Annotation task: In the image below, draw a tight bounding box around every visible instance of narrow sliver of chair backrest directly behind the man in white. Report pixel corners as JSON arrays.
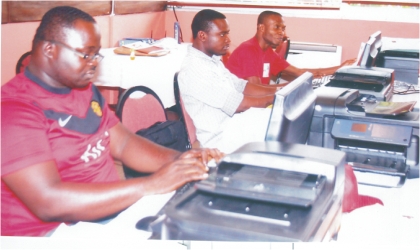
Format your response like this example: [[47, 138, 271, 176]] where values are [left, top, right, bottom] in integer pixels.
[[174, 72, 197, 145]]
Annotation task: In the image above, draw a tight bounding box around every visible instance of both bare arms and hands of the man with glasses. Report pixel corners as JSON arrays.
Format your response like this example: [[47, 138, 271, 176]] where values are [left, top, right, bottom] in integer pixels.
[[2, 124, 223, 221]]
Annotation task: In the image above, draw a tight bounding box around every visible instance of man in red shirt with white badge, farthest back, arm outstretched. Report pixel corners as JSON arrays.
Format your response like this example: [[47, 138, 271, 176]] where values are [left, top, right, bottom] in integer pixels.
[[227, 11, 355, 84]]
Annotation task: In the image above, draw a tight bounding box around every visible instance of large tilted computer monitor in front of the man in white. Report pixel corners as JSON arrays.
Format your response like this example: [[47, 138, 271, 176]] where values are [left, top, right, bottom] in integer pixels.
[[265, 72, 316, 144]]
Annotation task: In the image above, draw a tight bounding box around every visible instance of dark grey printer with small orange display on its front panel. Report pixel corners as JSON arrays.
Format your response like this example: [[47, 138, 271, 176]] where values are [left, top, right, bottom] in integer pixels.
[[307, 87, 419, 187]]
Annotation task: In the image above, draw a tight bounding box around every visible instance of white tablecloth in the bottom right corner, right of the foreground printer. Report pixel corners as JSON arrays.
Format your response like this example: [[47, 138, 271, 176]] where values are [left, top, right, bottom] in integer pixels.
[[338, 178, 420, 249]]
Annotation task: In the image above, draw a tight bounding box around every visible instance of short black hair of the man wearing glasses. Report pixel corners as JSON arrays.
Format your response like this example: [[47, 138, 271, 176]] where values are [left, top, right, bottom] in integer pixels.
[[32, 6, 96, 47]]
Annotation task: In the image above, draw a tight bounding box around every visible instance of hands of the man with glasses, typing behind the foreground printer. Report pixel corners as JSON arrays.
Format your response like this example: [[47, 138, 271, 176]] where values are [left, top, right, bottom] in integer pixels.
[[145, 149, 224, 195]]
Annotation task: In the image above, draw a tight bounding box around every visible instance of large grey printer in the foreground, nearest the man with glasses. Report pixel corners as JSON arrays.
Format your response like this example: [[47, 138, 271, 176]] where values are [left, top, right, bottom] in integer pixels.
[[150, 141, 345, 242]]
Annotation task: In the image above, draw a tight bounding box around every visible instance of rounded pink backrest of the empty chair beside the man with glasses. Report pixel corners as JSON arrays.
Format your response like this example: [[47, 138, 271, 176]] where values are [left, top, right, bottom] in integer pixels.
[[115, 86, 167, 133]]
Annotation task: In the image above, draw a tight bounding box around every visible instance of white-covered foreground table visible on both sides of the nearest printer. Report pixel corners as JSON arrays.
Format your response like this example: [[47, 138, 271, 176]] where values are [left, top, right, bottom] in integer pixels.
[[42, 179, 420, 250]]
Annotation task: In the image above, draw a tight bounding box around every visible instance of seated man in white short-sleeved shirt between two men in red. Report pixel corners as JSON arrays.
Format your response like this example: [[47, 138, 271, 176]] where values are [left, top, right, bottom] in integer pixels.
[[178, 9, 277, 153]]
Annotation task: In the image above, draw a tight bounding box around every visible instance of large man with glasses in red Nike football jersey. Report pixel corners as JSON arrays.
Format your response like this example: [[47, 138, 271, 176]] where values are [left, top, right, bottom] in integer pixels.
[[1, 7, 222, 236]]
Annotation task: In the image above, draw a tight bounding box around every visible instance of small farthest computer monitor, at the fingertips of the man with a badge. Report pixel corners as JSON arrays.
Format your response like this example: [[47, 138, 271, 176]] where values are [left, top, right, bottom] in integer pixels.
[[357, 31, 382, 68]]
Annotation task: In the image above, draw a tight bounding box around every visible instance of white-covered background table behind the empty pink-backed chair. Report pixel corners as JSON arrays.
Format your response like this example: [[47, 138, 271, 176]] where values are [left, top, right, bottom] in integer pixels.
[[94, 44, 188, 108]]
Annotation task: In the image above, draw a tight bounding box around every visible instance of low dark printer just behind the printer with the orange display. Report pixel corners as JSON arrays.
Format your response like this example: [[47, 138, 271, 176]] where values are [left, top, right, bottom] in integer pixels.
[[325, 66, 395, 101]]
